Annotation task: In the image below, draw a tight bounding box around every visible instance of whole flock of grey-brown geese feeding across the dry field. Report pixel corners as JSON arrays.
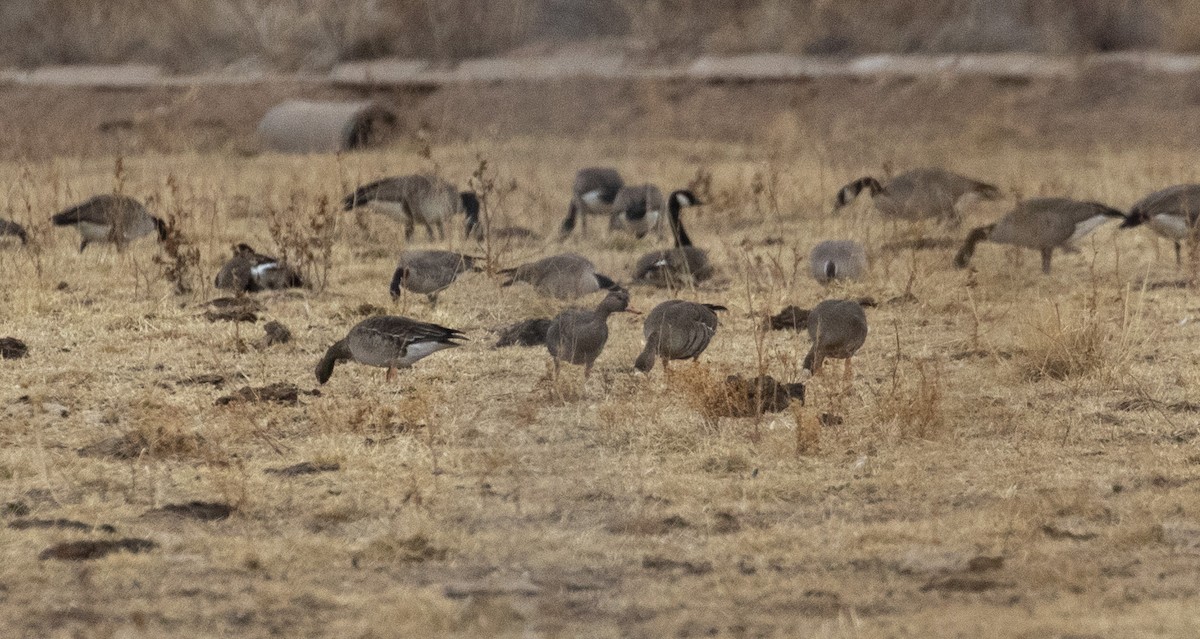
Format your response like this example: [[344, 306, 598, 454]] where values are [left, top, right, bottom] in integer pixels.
[[0, 167, 1200, 403]]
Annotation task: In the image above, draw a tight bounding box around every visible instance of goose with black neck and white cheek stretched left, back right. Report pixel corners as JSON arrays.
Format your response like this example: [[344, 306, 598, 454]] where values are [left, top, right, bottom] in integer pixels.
[[834, 168, 1001, 225]]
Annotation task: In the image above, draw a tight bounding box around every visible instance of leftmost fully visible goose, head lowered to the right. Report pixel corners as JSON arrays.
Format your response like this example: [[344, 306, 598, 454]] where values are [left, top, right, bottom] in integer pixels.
[[50, 195, 167, 252]]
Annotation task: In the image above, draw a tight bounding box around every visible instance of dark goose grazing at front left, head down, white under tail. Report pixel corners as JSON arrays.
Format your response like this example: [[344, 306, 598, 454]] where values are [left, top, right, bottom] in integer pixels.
[[317, 315, 467, 383]]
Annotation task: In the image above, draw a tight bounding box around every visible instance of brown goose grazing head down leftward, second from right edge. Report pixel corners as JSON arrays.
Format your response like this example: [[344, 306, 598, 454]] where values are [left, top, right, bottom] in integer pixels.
[[954, 197, 1124, 274]]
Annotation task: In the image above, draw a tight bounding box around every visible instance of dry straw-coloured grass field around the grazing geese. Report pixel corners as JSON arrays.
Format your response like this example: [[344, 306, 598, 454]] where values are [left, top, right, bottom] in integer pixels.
[[0, 77, 1200, 639]]
